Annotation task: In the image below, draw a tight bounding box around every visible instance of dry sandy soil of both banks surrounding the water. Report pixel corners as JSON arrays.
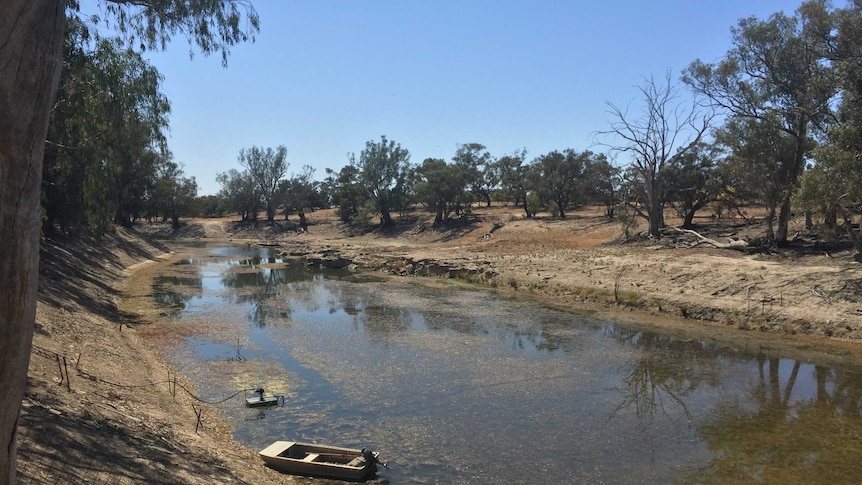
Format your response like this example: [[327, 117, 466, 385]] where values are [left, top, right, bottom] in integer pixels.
[[18, 207, 862, 484]]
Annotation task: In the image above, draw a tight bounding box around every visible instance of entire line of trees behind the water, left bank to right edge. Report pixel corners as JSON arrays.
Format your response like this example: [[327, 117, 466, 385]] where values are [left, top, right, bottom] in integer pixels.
[[35, 0, 862, 260]]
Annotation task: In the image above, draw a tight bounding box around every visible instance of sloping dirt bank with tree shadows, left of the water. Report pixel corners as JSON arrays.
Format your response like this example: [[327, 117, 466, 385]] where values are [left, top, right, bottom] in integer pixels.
[[18, 229, 302, 484]]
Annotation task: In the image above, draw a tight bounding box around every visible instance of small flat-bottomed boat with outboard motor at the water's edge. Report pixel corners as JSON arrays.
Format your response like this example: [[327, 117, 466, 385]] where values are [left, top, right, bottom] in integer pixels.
[[260, 441, 385, 481]]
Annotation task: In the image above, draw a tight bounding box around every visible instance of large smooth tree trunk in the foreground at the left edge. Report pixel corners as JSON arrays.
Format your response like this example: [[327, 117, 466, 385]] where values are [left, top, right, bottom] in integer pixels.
[[0, 0, 65, 483]]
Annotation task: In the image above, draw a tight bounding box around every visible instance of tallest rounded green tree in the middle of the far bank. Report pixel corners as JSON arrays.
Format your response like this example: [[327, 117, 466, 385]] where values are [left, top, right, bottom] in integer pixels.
[[357, 136, 410, 226]]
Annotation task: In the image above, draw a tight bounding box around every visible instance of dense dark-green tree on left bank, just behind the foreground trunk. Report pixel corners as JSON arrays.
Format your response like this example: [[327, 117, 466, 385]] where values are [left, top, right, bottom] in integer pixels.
[[42, 19, 170, 233]]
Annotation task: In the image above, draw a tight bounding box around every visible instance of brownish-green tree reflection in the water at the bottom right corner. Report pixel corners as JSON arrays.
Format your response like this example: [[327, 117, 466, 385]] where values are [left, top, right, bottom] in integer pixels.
[[692, 354, 862, 483]]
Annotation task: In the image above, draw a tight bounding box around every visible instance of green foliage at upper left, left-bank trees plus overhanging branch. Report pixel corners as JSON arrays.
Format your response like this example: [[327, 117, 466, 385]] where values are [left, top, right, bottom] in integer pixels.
[[42, 0, 259, 231]]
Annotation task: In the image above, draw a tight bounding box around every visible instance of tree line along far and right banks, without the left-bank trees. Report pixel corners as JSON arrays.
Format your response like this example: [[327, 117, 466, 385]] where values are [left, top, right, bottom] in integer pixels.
[[211, 0, 862, 260]]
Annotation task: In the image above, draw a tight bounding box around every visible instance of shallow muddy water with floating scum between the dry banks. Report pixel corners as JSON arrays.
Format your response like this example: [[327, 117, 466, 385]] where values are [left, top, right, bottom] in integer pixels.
[[153, 246, 862, 483]]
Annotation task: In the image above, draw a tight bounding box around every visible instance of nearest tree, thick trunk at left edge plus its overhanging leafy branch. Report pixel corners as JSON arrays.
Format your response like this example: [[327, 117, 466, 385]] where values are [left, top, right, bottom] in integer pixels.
[[0, 0, 259, 476]]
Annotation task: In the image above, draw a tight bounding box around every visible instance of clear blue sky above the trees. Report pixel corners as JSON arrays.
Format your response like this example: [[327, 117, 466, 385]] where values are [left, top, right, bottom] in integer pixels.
[[86, 0, 796, 195]]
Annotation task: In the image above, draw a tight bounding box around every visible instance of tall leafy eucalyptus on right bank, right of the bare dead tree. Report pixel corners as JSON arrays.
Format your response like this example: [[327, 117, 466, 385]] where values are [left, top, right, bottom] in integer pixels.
[[683, 4, 837, 244]]
